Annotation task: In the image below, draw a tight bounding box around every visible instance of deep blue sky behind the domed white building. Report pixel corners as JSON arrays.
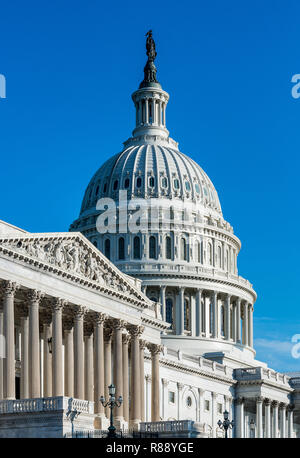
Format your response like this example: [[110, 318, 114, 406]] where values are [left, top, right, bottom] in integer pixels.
[[0, 0, 300, 370]]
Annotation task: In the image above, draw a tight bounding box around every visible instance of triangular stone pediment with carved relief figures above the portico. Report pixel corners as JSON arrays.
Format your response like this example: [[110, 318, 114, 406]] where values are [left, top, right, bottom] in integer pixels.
[[0, 232, 152, 307]]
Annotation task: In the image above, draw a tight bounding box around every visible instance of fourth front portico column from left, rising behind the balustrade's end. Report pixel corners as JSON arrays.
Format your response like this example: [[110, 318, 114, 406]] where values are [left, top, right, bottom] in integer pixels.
[[74, 307, 86, 399]]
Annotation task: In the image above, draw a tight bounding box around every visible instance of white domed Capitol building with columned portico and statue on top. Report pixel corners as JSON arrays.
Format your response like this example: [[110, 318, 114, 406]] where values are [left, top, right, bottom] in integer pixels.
[[0, 31, 300, 438]]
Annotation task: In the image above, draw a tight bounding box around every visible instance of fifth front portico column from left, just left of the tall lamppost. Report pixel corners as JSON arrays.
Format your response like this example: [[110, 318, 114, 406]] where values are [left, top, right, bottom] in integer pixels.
[[94, 313, 107, 420]]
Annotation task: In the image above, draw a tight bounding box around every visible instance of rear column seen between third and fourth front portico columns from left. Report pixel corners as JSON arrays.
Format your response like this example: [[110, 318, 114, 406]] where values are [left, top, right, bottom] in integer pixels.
[[64, 319, 74, 398]]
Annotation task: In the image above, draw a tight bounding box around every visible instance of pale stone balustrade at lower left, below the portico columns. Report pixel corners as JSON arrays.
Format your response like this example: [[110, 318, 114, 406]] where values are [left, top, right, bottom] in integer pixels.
[[0, 396, 94, 414]]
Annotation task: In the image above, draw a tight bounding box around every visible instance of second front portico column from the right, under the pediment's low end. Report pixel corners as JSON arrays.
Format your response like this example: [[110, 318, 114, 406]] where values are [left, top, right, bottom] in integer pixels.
[[128, 326, 144, 427]]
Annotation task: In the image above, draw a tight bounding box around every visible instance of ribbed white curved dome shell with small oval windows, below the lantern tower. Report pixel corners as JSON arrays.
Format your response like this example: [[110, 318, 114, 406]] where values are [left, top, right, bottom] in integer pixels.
[[81, 142, 222, 216]]
